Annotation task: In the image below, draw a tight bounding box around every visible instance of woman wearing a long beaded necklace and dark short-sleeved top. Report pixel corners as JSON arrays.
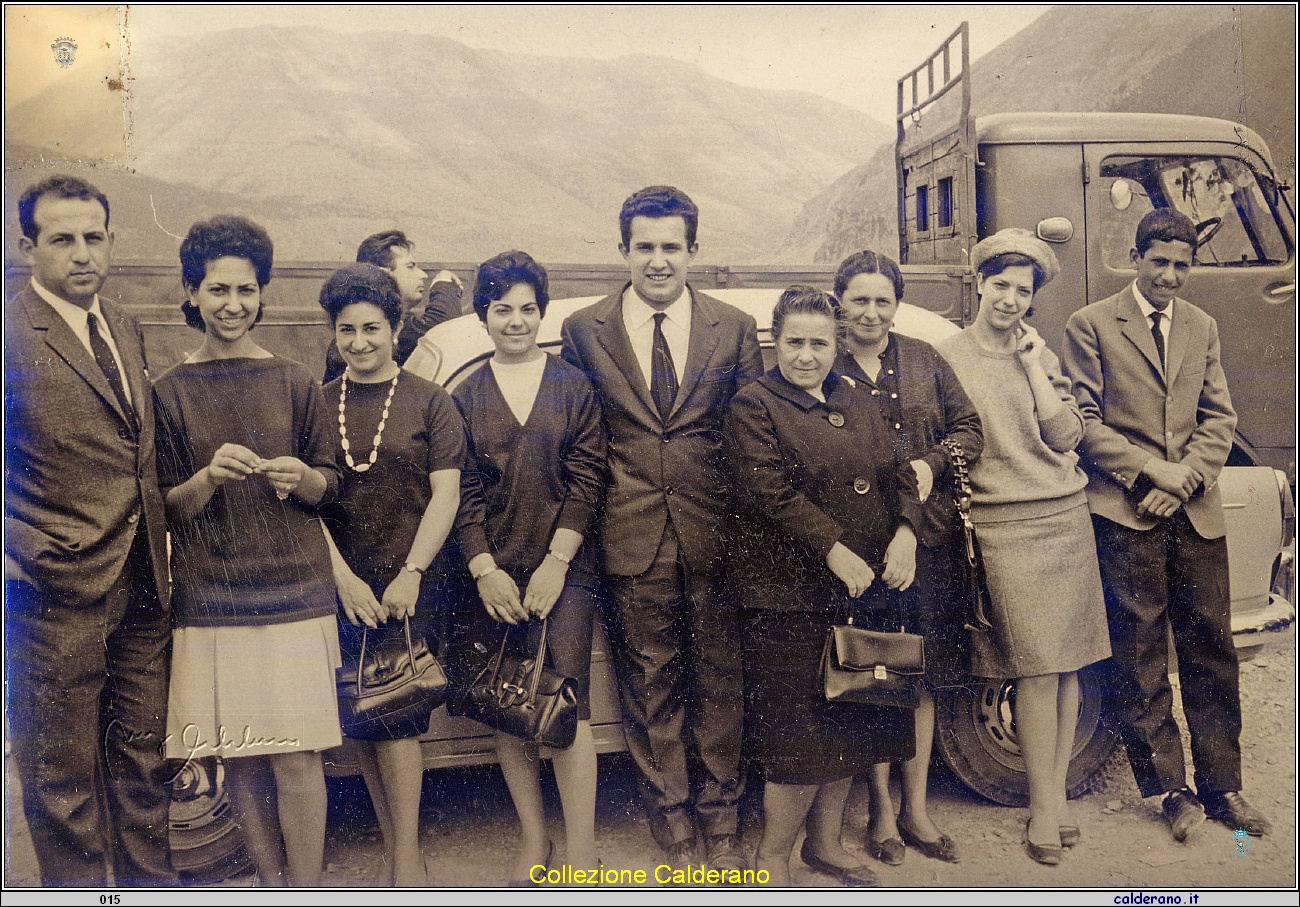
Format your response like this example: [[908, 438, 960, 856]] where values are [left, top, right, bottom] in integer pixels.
[[320, 264, 465, 888]]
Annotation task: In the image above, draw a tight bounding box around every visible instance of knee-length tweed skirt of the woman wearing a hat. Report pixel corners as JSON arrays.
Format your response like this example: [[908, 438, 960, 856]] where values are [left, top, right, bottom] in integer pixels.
[[971, 504, 1110, 677]]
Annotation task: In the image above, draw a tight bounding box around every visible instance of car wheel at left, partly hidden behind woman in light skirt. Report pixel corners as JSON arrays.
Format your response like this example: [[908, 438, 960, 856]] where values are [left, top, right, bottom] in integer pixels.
[[170, 756, 251, 884]]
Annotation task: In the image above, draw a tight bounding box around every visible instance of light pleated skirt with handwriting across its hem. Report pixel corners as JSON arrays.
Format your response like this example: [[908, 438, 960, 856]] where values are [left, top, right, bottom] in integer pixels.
[[166, 615, 343, 759]]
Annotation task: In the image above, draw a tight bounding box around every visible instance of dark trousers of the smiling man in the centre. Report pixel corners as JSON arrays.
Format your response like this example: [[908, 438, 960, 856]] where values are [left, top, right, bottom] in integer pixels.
[[610, 522, 745, 849]]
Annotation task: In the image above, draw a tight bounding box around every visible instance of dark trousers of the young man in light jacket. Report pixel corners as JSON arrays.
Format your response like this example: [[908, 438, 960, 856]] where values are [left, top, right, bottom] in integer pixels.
[[1092, 511, 1242, 797]]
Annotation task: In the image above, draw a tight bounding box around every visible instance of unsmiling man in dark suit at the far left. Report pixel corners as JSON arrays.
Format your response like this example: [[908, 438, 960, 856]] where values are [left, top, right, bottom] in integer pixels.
[[4, 177, 176, 886]]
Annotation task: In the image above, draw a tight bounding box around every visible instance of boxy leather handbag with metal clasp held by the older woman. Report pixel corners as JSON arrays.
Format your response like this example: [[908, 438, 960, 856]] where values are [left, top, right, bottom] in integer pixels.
[[822, 617, 926, 708]]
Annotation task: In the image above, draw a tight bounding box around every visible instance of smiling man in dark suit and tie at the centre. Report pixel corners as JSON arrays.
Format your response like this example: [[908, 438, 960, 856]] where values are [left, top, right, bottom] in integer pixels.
[[563, 186, 763, 869]]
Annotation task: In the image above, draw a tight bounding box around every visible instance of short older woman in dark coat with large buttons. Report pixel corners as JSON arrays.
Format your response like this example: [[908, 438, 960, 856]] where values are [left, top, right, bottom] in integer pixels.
[[727, 286, 920, 885]]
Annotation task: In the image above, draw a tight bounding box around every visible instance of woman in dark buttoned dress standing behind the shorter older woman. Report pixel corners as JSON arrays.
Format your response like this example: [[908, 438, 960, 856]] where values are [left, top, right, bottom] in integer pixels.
[[835, 249, 984, 865]]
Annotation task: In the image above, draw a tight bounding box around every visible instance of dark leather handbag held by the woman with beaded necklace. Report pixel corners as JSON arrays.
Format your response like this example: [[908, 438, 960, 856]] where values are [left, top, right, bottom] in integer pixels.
[[335, 617, 447, 741]]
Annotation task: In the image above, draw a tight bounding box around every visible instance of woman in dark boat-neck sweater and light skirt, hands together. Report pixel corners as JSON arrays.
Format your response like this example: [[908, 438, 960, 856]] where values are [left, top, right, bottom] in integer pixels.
[[153, 217, 341, 886]]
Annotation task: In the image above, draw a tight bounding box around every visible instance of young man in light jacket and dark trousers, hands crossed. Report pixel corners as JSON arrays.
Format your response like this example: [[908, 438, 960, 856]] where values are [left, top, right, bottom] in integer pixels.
[[1063, 208, 1270, 841]]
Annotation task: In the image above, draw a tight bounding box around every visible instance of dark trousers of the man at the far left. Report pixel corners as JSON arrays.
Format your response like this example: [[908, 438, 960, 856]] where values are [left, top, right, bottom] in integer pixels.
[[5, 531, 176, 886]]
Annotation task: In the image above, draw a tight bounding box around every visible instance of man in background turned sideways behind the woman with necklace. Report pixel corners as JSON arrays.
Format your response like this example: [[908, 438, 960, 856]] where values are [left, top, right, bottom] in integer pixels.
[[321, 230, 463, 385]]
